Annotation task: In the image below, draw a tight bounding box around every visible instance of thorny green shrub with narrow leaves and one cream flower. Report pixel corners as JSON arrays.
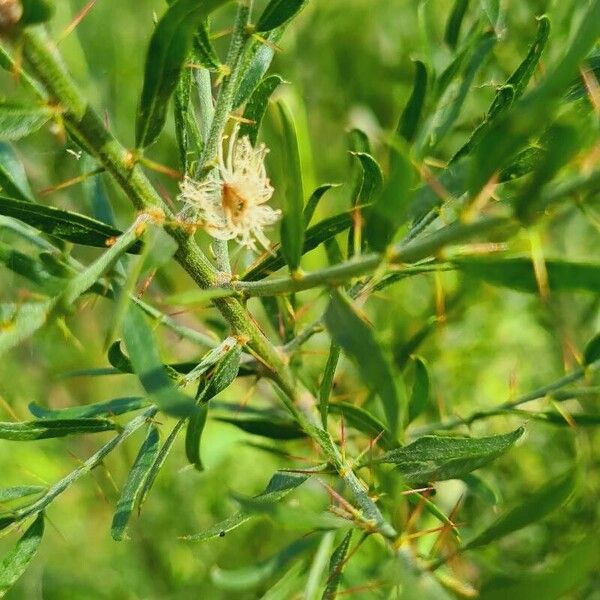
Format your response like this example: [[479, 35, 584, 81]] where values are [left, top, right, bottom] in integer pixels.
[[0, 0, 600, 598]]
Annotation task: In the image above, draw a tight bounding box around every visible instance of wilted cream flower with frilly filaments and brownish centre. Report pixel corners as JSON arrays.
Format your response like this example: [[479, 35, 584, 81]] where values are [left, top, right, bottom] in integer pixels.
[[180, 128, 281, 251]]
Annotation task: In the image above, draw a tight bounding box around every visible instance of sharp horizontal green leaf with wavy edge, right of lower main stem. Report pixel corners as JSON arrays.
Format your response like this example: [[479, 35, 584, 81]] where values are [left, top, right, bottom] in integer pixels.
[[371, 428, 524, 485]]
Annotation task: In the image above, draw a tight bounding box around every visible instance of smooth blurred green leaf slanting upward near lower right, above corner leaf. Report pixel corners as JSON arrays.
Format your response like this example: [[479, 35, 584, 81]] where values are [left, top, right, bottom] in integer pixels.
[[463, 471, 576, 550]]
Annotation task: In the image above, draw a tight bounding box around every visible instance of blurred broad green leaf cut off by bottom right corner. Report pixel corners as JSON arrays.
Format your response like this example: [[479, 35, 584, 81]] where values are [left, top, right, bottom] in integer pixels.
[[479, 534, 600, 600]]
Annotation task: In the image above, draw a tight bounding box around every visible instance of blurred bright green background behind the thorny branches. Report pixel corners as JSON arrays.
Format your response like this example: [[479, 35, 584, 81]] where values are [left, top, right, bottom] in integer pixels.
[[0, 0, 600, 600]]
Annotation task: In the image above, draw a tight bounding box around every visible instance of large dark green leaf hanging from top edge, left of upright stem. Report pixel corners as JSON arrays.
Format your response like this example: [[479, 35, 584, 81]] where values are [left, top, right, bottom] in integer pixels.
[[135, 0, 228, 148]]
